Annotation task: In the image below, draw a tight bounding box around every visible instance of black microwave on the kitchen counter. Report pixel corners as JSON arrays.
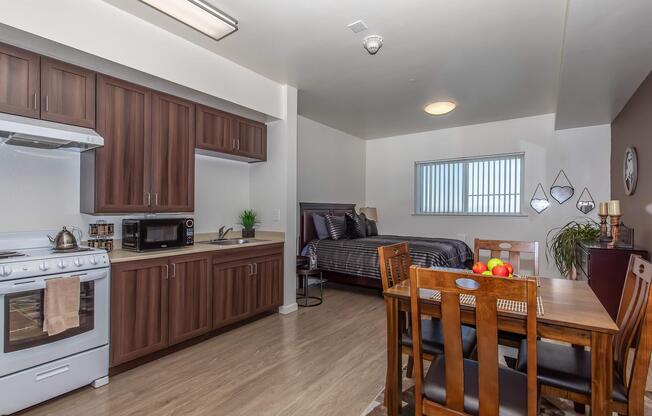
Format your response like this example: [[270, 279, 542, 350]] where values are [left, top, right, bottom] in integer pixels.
[[122, 218, 195, 251]]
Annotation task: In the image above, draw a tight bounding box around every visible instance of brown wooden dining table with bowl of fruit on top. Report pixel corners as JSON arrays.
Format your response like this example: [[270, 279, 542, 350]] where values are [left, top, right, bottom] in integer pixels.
[[384, 278, 618, 415]]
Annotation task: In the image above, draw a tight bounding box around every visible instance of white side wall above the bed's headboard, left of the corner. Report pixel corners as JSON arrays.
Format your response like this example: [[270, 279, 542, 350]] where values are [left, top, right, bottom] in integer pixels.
[[298, 116, 365, 204]]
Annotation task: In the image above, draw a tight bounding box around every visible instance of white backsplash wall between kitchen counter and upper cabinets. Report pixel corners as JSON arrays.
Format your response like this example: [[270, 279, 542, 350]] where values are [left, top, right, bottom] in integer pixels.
[[0, 145, 249, 238]]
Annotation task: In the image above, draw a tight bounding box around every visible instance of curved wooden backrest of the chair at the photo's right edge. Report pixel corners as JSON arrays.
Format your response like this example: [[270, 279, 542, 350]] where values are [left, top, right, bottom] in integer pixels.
[[614, 255, 652, 401]]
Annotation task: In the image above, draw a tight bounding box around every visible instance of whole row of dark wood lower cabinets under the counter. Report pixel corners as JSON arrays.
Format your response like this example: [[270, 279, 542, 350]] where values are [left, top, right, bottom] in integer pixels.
[[111, 243, 283, 367]]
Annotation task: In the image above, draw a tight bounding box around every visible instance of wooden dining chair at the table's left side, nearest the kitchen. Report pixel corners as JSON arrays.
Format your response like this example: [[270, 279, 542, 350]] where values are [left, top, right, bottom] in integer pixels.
[[378, 243, 476, 377]]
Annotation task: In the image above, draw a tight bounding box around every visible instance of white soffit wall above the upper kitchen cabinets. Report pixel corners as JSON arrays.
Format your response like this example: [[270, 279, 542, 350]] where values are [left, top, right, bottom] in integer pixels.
[[0, 0, 283, 118]]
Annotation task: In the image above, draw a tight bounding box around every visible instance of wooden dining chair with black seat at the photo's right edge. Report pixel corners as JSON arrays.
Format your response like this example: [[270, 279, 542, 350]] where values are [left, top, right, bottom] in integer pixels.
[[516, 255, 652, 415]]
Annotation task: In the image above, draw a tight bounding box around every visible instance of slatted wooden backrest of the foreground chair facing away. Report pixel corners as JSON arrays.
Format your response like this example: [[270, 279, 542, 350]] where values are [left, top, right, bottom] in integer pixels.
[[410, 266, 537, 416]]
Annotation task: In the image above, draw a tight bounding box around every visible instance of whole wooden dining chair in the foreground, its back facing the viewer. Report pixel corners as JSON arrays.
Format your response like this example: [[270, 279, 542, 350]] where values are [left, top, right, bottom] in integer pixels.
[[410, 266, 539, 416]]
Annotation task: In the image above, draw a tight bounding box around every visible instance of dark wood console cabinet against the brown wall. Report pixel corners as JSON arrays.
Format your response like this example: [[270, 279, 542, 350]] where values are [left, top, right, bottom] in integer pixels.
[[577, 243, 648, 320]]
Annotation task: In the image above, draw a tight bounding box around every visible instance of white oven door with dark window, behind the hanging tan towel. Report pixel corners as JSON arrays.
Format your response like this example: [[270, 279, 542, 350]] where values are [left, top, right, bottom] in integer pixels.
[[0, 269, 109, 377]]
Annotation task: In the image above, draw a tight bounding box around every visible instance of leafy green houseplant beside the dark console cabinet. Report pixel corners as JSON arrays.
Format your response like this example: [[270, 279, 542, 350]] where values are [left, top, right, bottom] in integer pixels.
[[546, 220, 600, 279]]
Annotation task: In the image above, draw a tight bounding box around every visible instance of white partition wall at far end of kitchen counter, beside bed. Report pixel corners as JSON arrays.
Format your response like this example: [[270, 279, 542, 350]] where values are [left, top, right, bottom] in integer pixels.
[[250, 86, 298, 313]]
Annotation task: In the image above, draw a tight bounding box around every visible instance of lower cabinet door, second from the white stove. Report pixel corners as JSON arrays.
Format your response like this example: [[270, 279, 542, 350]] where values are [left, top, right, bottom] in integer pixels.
[[169, 255, 212, 345]]
